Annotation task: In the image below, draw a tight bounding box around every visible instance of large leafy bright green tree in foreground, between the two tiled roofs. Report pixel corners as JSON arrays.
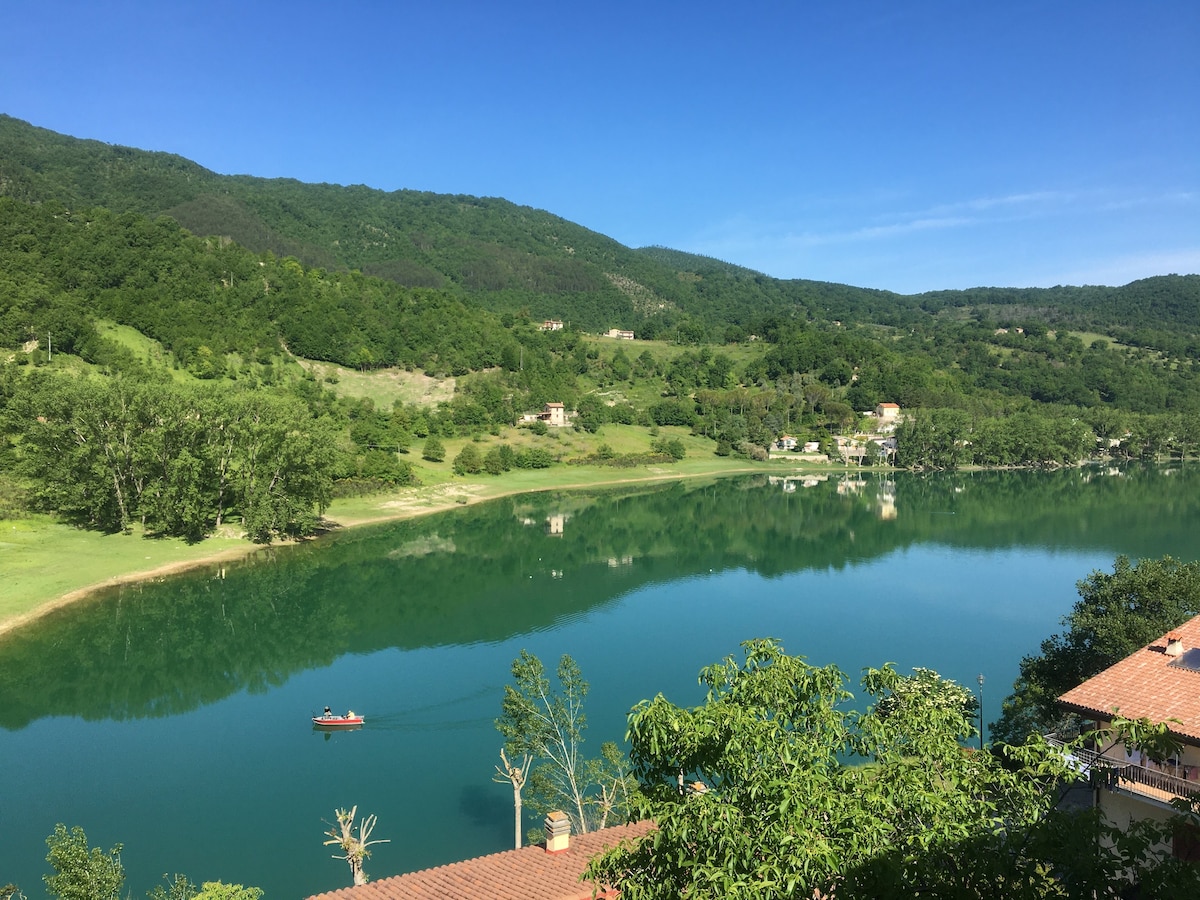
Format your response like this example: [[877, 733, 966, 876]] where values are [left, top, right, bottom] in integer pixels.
[[589, 640, 1200, 900]]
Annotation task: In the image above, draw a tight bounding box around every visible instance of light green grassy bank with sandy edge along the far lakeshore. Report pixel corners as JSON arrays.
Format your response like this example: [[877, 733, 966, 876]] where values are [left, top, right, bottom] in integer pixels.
[[0, 457, 806, 636]]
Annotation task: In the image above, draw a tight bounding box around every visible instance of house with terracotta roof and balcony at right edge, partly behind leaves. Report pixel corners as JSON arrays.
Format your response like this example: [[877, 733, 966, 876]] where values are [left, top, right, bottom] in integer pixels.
[[1058, 616, 1200, 859]]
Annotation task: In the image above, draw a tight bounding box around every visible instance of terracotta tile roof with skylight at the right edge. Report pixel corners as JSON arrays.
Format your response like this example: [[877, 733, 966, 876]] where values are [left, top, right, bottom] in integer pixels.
[[1058, 616, 1200, 744]]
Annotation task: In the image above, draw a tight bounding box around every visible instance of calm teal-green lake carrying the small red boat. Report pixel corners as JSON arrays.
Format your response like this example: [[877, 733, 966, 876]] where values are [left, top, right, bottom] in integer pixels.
[[7, 467, 1200, 900]]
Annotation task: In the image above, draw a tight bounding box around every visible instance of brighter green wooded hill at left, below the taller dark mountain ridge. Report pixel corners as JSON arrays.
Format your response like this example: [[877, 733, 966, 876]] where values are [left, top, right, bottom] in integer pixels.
[[0, 198, 515, 378]]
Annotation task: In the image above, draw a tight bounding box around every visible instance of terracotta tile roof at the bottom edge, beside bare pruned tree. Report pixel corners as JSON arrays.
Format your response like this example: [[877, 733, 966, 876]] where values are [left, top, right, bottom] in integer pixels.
[[308, 822, 653, 900]]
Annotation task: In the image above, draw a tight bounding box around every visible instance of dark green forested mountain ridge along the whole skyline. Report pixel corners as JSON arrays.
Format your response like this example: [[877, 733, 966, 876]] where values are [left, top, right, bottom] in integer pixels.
[[0, 115, 1200, 343]]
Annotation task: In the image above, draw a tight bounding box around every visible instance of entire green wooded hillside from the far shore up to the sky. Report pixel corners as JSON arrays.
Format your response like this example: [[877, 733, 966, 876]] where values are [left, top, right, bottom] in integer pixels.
[[0, 116, 1200, 540]]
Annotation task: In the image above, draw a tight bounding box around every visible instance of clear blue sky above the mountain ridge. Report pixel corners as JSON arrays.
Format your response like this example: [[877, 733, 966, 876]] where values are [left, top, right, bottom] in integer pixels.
[[0, 0, 1200, 293]]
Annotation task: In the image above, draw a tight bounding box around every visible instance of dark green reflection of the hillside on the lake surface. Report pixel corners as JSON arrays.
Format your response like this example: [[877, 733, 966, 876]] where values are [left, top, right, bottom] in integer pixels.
[[0, 468, 1200, 728]]
